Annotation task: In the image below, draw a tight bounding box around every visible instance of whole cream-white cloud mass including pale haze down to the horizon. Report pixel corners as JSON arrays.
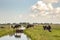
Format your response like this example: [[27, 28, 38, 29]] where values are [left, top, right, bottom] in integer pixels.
[[0, 0, 60, 23]]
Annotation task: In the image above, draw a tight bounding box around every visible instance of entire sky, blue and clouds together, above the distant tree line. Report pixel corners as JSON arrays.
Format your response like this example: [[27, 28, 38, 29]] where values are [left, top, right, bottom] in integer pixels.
[[0, 0, 60, 23]]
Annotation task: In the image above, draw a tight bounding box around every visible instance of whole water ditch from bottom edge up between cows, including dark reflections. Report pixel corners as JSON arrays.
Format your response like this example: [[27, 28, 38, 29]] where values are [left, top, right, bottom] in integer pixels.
[[0, 26, 31, 40]]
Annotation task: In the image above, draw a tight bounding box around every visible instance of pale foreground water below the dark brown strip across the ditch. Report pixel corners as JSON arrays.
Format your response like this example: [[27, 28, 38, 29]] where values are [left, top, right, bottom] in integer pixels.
[[0, 33, 30, 40]]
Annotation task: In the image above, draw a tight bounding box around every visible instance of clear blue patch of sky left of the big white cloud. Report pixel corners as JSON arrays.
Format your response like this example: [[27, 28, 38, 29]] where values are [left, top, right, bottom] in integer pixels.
[[0, 0, 37, 14]]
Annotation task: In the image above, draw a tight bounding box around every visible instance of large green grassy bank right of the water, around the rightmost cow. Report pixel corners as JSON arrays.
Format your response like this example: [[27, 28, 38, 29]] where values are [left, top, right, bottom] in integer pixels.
[[24, 25, 60, 40]]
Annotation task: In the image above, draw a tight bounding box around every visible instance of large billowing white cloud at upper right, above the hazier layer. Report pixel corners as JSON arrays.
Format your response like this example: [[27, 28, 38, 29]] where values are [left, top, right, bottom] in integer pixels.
[[32, 0, 60, 15]]
